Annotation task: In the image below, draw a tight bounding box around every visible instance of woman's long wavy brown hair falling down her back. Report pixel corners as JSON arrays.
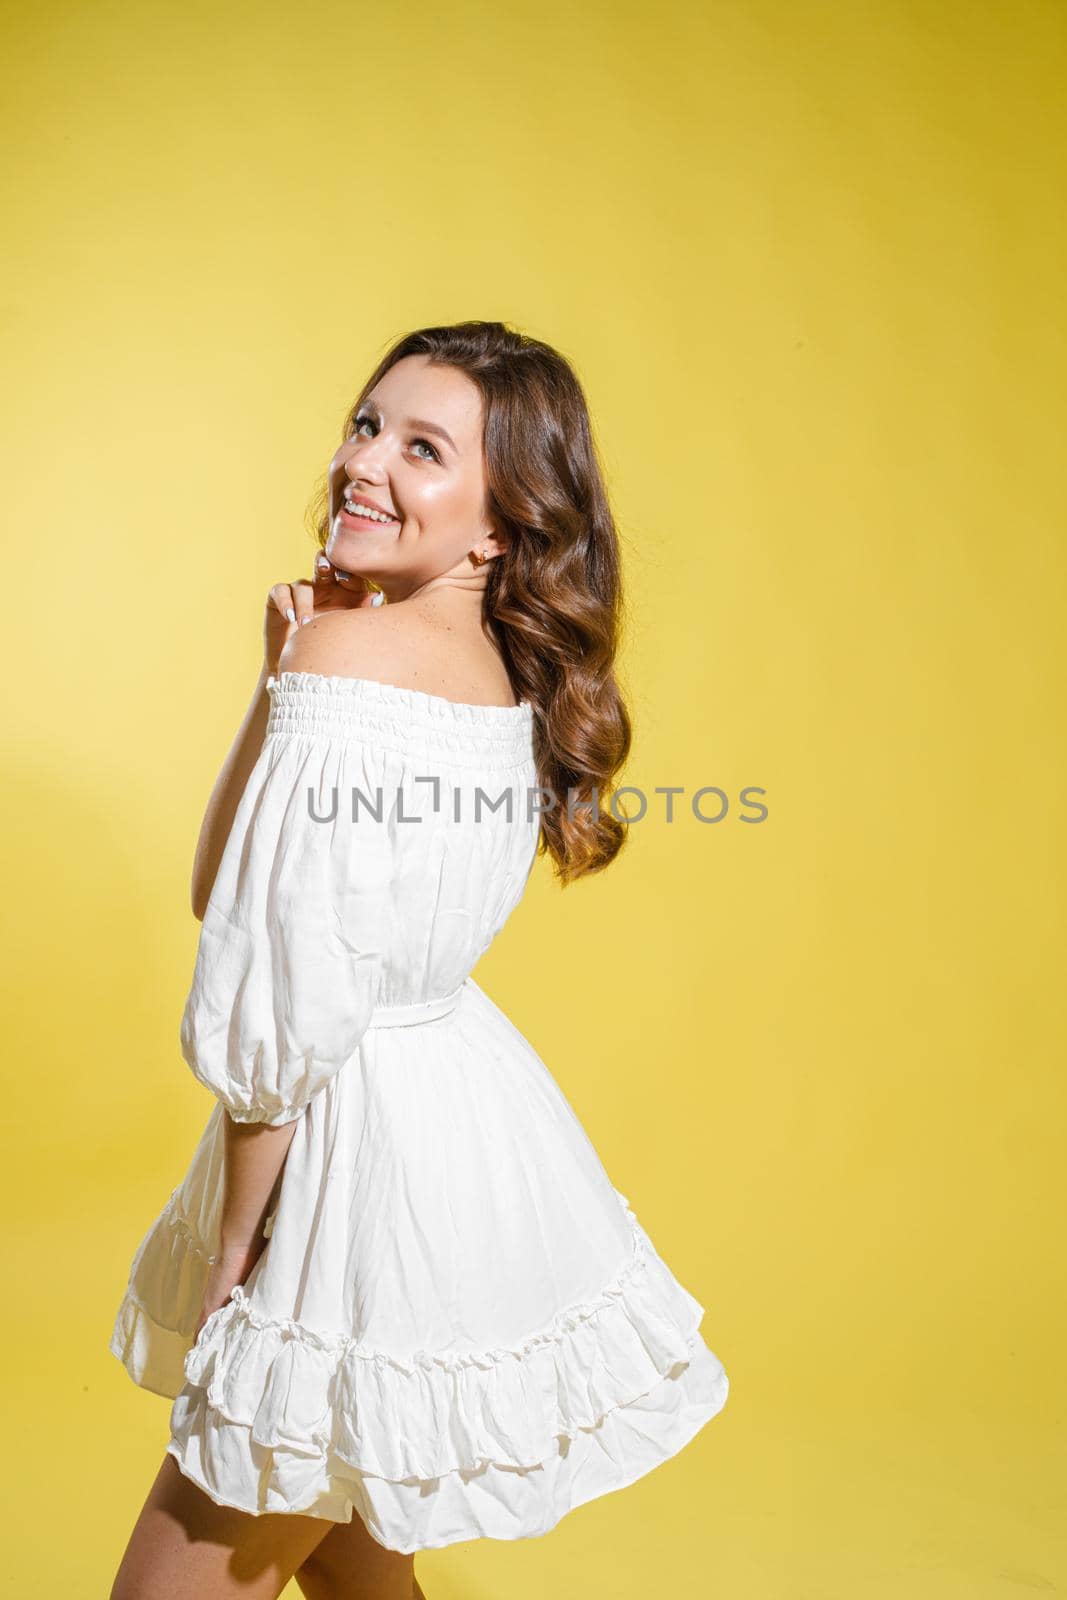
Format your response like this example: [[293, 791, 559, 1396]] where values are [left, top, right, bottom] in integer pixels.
[[309, 322, 630, 885]]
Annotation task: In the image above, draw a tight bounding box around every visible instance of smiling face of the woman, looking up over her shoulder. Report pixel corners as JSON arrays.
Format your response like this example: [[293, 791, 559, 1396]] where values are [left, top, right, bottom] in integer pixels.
[[326, 355, 502, 600]]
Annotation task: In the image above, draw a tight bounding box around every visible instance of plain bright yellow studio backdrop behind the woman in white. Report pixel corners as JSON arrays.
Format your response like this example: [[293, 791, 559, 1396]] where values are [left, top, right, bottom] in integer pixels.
[[0, 0, 1067, 1600]]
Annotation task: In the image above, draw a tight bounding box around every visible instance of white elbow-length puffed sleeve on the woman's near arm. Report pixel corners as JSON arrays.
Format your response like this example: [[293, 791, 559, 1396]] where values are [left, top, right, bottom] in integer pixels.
[[181, 734, 392, 1128]]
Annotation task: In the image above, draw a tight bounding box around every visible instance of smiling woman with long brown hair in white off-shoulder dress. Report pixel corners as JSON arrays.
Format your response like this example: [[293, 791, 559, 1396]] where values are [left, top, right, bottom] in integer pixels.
[[110, 323, 728, 1600]]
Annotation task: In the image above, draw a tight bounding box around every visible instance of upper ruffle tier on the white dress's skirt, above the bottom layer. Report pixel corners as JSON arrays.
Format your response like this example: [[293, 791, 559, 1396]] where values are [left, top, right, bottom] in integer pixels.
[[171, 1195, 704, 1480]]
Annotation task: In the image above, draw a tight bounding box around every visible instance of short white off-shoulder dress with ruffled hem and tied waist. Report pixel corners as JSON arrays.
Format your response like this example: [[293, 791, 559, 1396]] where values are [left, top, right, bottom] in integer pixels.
[[110, 672, 728, 1552]]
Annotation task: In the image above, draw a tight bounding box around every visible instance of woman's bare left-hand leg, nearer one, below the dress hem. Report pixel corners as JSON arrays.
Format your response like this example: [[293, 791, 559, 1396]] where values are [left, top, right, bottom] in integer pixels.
[[110, 1454, 340, 1600]]
